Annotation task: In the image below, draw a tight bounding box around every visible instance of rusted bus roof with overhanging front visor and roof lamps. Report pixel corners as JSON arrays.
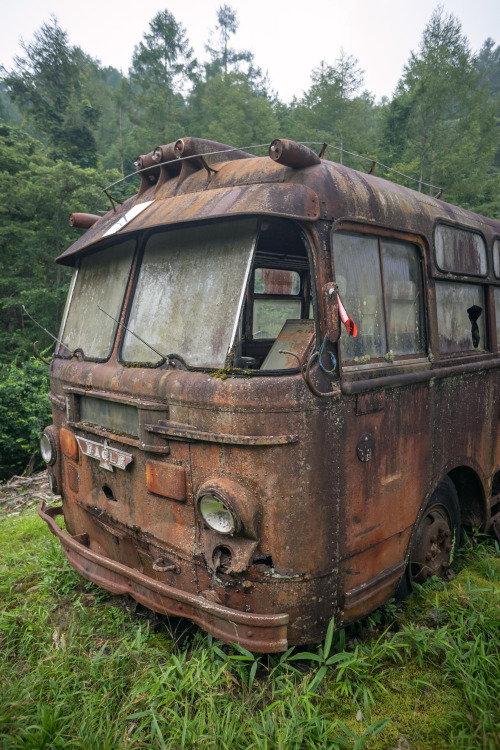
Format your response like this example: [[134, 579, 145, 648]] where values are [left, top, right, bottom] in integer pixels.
[[57, 138, 500, 266]]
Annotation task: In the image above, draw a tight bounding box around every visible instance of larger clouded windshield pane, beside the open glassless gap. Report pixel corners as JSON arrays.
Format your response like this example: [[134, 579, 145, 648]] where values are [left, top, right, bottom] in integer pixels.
[[121, 219, 257, 368]]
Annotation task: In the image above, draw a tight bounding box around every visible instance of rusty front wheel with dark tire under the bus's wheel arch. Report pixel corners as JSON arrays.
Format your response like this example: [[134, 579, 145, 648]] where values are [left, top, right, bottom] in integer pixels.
[[396, 477, 461, 600]]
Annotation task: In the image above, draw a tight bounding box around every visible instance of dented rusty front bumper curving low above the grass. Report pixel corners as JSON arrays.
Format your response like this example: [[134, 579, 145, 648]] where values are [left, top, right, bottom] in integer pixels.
[[38, 503, 288, 653]]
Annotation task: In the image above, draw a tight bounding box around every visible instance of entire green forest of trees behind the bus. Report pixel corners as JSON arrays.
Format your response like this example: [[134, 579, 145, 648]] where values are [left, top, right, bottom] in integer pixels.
[[0, 5, 500, 479]]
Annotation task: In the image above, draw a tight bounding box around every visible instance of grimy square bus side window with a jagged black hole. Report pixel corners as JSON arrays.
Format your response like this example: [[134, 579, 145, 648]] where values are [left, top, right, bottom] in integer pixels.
[[436, 281, 486, 354]]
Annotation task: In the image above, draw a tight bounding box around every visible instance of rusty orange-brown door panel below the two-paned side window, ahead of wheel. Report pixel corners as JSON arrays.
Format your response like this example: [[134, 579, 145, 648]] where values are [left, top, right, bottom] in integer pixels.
[[340, 385, 432, 621]]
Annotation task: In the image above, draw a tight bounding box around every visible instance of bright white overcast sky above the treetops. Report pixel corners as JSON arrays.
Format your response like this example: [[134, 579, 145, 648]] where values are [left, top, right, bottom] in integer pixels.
[[0, 0, 500, 101]]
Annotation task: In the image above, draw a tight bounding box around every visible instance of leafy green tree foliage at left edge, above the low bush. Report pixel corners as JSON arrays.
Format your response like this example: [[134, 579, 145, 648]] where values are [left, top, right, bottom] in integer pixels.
[[0, 125, 131, 363]]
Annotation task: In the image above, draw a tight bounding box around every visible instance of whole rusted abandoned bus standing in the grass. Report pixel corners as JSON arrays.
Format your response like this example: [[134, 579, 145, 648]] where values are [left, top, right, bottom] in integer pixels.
[[39, 138, 500, 652]]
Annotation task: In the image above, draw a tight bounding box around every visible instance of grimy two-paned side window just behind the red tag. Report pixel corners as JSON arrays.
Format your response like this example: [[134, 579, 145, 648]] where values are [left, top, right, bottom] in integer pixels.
[[333, 232, 424, 362]]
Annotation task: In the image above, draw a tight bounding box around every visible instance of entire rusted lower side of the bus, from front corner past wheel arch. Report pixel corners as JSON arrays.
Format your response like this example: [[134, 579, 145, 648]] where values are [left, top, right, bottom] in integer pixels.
[[340, 369, 492, 622]]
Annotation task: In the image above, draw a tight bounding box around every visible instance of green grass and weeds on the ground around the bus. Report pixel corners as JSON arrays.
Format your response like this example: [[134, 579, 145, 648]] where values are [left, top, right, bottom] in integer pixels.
[[0, 510, 500, 750]]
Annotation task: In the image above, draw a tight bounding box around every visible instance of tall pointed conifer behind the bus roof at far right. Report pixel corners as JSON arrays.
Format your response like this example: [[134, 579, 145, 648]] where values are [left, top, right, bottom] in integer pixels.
[[384, 6, 495, 207]]
